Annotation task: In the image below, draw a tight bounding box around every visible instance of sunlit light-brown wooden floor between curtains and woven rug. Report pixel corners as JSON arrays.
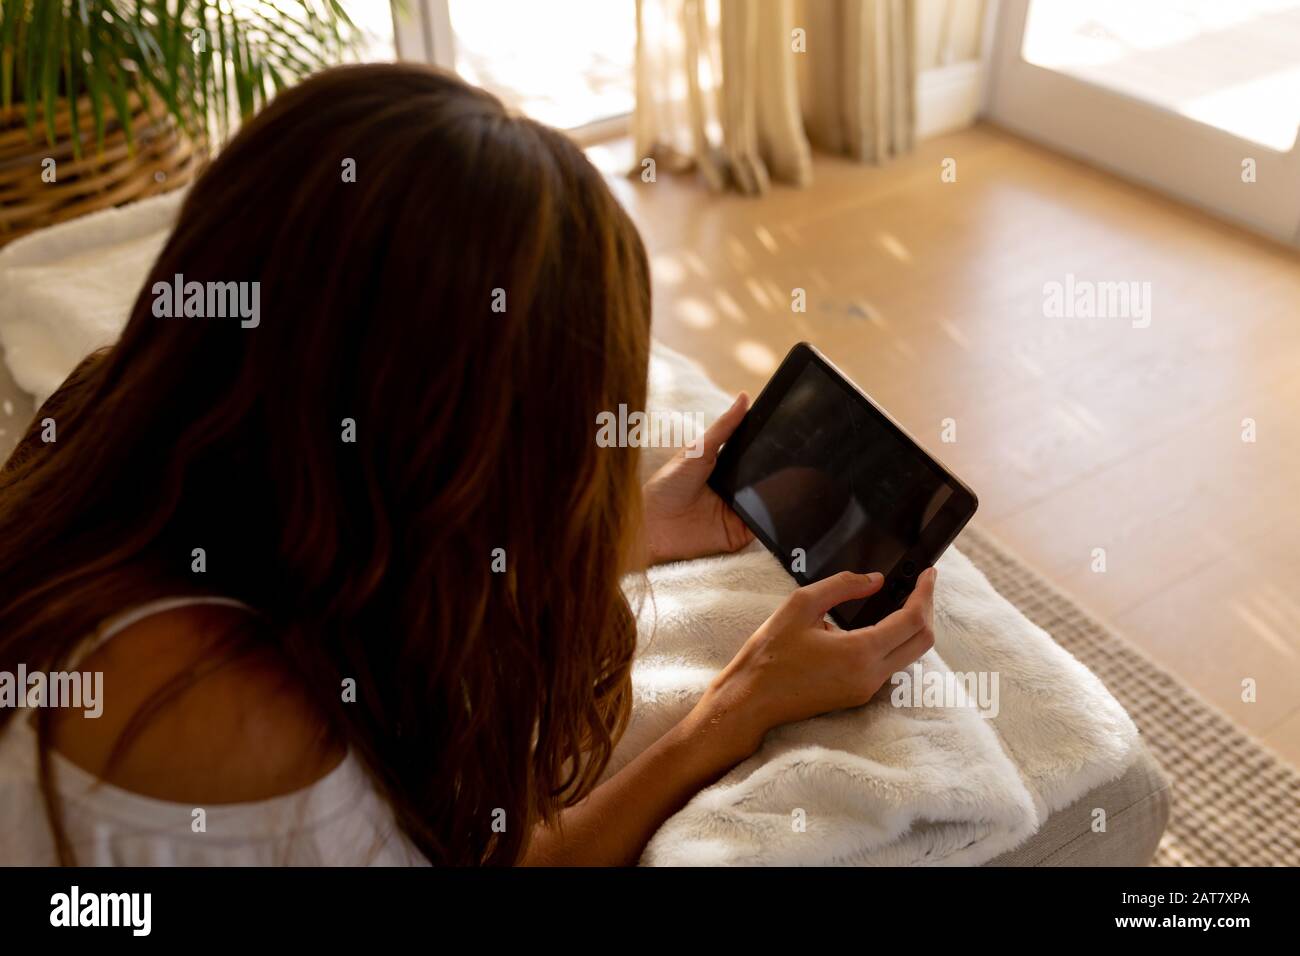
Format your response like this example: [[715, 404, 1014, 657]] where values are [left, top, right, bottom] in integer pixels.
[[605, 126, 1300, 766]]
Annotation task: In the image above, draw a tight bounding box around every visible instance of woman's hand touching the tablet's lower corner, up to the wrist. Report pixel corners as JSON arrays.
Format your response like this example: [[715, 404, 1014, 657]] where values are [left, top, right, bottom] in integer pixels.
[[692, 568, 936, 762]]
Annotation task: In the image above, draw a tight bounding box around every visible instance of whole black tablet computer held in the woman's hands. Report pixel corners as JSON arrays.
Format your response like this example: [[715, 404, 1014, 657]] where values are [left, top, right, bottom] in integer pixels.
[[709, 342, 978, 630]]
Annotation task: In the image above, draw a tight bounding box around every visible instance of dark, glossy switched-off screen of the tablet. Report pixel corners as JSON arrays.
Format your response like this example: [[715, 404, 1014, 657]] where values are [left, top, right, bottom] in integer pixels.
[[733, 362, 953, 618]]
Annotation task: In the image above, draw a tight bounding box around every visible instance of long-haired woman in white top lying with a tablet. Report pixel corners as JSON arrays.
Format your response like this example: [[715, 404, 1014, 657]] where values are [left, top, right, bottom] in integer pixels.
[[0, 65, 932, 864]]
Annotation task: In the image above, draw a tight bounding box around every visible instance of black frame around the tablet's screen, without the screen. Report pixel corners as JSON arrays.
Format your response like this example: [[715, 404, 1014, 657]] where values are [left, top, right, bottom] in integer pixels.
[[709, 342, 979, 630]]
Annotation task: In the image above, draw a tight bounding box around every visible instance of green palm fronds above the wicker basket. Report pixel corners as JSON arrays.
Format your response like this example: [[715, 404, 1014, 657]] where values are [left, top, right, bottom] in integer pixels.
[[0, 0, 359, 159]]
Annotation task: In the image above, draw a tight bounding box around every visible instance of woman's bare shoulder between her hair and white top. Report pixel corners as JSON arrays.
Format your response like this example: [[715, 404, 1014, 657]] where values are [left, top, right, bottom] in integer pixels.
[[52, 605, 345, 805]]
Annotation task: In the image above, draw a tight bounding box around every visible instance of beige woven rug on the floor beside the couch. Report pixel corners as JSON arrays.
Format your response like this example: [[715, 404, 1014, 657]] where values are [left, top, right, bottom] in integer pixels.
[[957, 528, 1300, 866]]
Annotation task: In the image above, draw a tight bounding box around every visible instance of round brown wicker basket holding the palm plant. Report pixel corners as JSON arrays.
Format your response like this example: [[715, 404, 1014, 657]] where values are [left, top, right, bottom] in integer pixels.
[[0, 96, 207, 246]]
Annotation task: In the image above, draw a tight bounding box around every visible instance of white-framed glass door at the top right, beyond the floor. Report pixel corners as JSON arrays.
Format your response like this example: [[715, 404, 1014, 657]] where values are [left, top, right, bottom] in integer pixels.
[[988, 0, 1300, 243]]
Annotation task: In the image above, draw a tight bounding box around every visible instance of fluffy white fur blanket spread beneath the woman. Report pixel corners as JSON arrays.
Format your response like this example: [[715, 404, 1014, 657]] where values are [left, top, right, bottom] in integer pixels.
[[0, 194, 1136, 865]]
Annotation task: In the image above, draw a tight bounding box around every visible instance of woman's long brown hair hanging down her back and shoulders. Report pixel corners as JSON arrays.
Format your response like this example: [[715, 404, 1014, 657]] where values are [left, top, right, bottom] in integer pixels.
[[0, 65, 650, 864]]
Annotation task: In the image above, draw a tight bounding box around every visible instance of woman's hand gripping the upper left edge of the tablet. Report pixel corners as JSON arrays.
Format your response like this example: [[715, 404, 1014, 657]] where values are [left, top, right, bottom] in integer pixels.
[[642, 392, 754, 564]]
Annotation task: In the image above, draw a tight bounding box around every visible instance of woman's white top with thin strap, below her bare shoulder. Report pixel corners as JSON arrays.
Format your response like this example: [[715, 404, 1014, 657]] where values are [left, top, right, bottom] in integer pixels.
[[0, 597, 428, 866]]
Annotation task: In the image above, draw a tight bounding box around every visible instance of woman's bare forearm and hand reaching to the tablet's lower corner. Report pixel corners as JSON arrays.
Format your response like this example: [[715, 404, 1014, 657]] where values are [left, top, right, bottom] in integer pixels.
[[524, 568, 935, 866]]
